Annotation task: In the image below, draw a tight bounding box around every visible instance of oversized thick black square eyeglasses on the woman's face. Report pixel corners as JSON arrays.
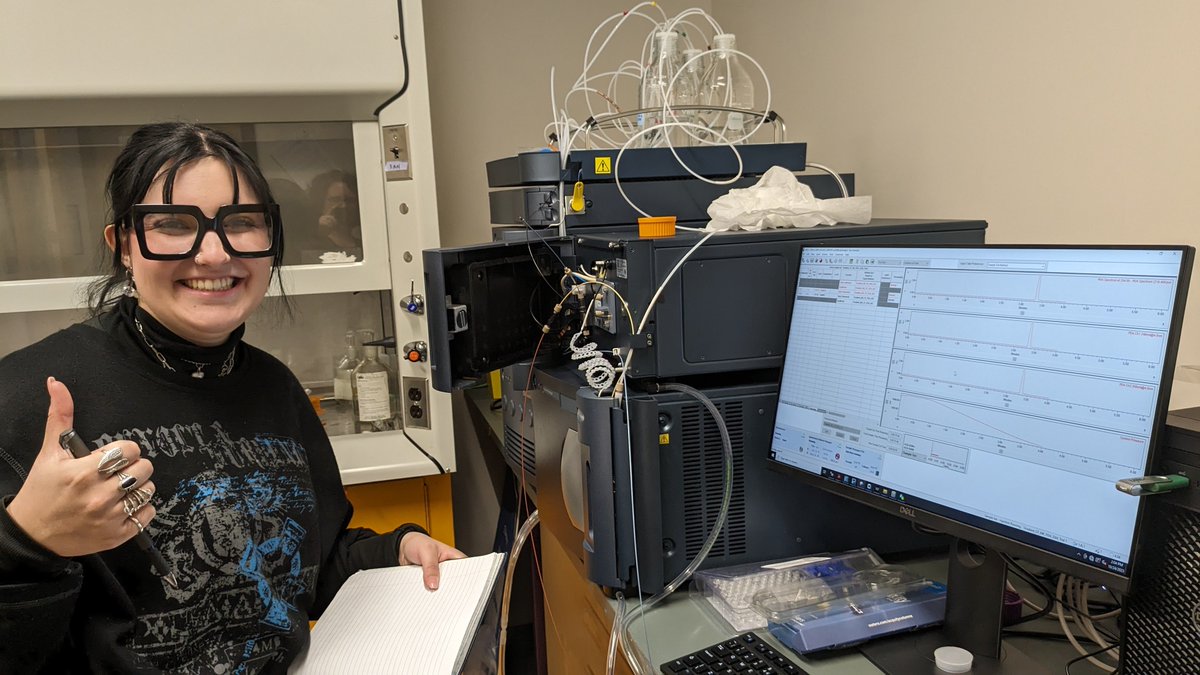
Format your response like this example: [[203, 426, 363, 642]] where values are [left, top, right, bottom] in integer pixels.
[[130, 204, 283, 261]]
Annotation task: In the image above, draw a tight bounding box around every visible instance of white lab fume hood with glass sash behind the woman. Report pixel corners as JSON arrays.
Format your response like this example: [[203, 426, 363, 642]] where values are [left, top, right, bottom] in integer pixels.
[[0, 0, 456, 484]]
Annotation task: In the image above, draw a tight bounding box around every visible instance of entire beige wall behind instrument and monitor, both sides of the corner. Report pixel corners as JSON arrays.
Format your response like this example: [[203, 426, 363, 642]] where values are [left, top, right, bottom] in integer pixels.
[[426, 0, 1200, 405]]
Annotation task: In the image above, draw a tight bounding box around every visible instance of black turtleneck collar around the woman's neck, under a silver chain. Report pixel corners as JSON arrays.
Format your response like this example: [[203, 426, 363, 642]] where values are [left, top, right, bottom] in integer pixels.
[[113, 298, 246, 378]]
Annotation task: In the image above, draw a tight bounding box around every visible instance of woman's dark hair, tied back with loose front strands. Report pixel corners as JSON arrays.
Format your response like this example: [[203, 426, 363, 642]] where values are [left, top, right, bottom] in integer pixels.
[[88, 121, 290, 315]]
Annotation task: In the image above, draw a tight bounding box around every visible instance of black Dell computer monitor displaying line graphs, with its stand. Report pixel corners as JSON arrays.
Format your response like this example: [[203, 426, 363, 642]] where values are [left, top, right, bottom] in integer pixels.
[[769, 245, 1193, 671]]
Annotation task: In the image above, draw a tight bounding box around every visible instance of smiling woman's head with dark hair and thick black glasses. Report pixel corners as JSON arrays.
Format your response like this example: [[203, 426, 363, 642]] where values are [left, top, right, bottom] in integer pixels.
[[91, 124, 283, 347]]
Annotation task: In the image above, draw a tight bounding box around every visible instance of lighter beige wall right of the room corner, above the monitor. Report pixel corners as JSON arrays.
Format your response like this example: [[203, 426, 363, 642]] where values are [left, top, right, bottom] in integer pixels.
[[714, 0, 1200, 398]]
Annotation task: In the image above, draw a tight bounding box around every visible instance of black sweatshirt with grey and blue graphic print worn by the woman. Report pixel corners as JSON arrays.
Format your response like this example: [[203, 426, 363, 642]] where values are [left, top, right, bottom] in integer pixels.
[[0, 299, 419, 675]]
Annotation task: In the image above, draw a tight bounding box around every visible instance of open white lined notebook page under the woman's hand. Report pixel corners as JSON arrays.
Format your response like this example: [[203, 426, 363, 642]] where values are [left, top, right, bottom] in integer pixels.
[[290, 554, 504, 675]]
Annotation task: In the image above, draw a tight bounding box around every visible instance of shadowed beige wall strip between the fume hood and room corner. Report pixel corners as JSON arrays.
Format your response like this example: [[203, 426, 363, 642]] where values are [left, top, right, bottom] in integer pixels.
[[425, 0, 712, 246]]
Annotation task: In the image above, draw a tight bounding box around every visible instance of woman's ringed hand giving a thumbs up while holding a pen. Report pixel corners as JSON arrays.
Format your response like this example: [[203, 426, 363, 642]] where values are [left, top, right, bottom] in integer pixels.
[[7, 377, 156, 557]]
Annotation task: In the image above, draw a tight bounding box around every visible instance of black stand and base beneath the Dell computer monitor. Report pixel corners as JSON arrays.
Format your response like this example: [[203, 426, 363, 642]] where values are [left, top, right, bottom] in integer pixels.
[[859, 539, 1050, 675]]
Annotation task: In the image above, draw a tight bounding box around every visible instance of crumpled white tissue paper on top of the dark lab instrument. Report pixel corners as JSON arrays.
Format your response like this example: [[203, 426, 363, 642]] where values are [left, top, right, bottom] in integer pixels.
[[704, 167, 871, 232]]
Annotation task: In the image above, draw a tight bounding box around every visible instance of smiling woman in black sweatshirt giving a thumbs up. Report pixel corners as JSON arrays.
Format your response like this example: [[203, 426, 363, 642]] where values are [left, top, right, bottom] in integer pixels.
[[0, 123, 462, 673]]
